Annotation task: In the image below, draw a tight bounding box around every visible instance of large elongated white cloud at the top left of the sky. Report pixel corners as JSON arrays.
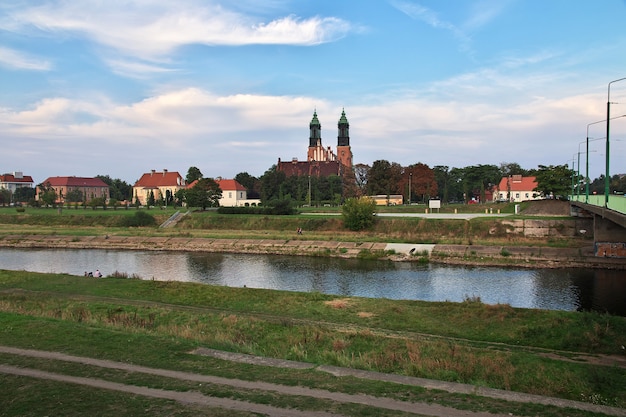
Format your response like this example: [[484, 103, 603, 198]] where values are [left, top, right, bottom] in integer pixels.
[[11, 0, 350, 59]]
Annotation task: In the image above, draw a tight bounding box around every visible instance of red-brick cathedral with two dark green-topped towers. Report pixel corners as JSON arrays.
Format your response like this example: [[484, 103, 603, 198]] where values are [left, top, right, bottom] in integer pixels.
[[277, 110, 352, 178]]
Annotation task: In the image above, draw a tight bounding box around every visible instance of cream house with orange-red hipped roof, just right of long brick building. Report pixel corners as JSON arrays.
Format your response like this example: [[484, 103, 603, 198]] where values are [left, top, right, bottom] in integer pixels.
[[133, 169, 185, 206]]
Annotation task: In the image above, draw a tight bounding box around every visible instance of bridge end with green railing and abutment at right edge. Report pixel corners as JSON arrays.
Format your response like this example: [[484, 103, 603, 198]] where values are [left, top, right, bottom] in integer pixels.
[[570, 194, 626, 258]]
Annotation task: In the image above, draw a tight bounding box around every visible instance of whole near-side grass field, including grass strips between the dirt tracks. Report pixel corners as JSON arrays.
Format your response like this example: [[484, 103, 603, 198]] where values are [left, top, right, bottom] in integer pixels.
[[0, 271, 626, 416]]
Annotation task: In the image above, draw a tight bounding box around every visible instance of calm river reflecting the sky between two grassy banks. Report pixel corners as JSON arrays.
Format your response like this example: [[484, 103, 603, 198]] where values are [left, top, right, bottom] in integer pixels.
[[0, 248, 626, 316]]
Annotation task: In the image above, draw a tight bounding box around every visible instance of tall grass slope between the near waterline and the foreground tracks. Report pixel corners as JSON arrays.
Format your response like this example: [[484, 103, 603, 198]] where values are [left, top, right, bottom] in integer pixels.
[[0, 271, 626, 404]]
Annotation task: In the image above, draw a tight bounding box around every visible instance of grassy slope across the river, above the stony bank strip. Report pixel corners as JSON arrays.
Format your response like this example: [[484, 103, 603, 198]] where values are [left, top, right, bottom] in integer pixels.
[[0, 205, 590, 247]]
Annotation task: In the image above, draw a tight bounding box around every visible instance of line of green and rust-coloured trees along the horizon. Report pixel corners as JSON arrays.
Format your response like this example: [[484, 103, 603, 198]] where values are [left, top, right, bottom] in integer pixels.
[[0, 160, 626, 208]]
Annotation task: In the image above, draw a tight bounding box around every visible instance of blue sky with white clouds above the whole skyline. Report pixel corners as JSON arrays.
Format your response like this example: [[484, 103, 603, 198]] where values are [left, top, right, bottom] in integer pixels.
[[0, 0, 626, 183]]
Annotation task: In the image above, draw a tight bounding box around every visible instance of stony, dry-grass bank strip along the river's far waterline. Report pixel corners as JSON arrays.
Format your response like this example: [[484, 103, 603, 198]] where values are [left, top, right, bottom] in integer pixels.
[[0, 234, 626, 270]]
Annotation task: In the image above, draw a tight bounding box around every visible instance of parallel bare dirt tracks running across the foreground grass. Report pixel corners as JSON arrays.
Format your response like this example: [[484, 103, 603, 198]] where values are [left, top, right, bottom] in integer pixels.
[[0, 346, 626, 417]]
